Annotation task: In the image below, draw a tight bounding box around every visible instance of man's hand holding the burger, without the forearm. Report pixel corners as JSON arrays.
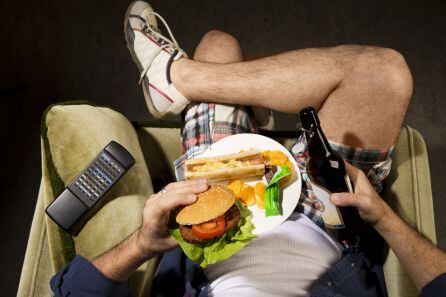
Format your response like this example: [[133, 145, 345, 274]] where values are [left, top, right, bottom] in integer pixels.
[[137, 179, 208, 256]]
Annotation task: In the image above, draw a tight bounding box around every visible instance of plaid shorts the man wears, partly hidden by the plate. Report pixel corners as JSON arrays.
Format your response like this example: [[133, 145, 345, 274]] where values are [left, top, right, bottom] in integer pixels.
[[174, 103, 393, 228]]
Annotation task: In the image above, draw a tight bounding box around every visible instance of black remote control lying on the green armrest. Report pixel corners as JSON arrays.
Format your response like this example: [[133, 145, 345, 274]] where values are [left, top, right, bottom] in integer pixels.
[[45, 141, 135, 234]]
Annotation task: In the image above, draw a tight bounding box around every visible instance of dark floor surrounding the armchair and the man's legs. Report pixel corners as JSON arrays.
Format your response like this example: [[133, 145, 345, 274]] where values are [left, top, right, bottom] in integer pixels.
[[0, 0, 446, 296]]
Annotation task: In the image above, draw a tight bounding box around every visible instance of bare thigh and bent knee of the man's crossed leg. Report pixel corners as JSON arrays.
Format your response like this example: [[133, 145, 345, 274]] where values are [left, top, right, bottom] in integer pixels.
[[319, 46, 412, 151]]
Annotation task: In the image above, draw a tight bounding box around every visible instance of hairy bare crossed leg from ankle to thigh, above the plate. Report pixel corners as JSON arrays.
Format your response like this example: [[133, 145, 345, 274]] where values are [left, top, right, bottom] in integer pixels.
[[171, 46, 412, 149]]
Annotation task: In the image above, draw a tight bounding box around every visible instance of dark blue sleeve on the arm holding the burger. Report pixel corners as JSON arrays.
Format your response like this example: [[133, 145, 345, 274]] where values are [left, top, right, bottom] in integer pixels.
[[50, 256, 131, 297]]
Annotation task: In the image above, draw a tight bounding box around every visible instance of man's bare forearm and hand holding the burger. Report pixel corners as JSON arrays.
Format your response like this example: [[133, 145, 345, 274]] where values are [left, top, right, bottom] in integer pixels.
[[93, 180, 208, 281]]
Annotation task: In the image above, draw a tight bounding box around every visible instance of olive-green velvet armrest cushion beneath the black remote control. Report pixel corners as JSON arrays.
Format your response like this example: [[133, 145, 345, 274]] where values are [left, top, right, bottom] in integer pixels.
[[42, 102, 157, 296]]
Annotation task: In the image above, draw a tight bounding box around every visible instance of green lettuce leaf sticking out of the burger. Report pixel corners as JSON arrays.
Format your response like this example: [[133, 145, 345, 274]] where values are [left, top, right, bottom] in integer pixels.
[[170, 200, 257, 268]]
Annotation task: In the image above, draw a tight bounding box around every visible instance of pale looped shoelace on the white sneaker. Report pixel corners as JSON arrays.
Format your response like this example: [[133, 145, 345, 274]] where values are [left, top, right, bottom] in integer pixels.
[[139, 11, 186, 84]]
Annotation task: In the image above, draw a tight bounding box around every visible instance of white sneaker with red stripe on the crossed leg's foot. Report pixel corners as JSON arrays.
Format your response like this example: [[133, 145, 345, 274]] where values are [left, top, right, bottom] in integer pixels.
[[124, 1, 189, 119]]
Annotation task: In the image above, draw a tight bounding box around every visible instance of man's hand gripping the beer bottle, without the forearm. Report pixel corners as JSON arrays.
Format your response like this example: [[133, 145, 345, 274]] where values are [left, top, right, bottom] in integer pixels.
[[330, 162, 392, 226]]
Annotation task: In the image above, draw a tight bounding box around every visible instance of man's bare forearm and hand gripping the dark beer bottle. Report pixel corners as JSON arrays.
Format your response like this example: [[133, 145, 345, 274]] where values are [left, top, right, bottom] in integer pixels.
[[330, 163, 446, 289]]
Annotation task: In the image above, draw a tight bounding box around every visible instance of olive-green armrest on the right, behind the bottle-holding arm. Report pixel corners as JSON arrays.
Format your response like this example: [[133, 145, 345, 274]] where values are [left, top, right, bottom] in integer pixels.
[[383, 126, 436, 297]]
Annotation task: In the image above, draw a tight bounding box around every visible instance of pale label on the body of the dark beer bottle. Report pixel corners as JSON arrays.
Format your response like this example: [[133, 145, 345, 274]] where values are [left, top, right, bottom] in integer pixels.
[[311, 180, 344, 229]]
